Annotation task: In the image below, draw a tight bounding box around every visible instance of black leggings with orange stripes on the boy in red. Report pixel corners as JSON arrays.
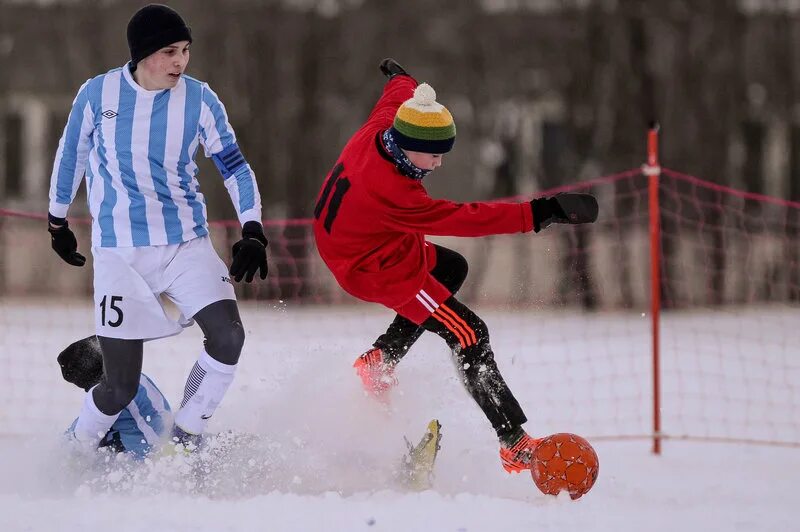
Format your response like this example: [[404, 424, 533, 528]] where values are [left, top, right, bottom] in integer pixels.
[[374, 246, 527, 437]]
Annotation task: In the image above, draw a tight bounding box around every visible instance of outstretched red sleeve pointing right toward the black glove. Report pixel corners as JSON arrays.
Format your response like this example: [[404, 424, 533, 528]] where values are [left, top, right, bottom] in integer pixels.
[[382, 180, 533, 236]]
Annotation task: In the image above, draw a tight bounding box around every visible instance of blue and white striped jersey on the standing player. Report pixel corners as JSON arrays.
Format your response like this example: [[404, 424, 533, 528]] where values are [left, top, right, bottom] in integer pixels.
[[49, 65, 261, 247]]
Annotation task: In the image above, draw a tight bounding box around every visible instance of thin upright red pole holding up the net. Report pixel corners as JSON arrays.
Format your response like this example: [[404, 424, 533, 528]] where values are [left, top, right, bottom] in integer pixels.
[[642, 123, 661, 454]]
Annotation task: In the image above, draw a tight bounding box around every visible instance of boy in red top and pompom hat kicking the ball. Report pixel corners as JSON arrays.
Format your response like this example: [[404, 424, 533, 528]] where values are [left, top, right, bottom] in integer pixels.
[[314, 59, 598, 472]]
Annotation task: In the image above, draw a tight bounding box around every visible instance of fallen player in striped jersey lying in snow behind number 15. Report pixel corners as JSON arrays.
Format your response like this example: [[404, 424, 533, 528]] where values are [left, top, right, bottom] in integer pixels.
[[58, 336, 172, 460]]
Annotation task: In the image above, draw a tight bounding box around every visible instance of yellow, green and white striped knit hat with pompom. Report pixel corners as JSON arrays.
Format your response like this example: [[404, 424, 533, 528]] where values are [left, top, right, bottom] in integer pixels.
[[391, 83, 456, 153]]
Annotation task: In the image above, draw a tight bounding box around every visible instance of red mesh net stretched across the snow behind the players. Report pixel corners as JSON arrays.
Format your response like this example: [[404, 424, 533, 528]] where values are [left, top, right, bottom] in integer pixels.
[[0, 170, 800, 446]]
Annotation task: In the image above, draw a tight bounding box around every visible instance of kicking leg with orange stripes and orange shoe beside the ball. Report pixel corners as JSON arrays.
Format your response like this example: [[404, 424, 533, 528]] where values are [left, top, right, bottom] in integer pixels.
[[422, 296, 538, 472]]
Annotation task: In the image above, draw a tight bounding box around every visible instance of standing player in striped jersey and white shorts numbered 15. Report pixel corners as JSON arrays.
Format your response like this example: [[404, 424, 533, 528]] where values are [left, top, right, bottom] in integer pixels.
[[49, 4, 267, 454]]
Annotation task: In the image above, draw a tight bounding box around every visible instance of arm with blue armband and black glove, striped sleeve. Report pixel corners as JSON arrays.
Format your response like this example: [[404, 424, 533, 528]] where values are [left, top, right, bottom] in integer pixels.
[[200, 85, 267, 283]]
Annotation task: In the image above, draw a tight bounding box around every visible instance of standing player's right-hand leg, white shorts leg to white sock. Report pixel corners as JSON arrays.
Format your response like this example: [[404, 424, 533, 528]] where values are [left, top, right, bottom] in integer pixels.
[[164, 237, 244, 440]]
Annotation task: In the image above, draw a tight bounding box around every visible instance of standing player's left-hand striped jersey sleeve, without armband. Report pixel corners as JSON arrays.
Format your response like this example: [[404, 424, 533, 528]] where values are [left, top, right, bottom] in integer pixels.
[[49, 80, 94, 218]]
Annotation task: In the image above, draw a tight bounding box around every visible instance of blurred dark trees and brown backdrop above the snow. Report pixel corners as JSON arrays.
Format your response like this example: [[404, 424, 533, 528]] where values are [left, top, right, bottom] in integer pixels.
[[0, 0, 800, 308]]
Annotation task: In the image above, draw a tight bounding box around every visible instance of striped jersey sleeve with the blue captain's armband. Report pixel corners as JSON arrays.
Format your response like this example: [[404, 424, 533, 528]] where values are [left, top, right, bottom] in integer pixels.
[[200, 84, 261, 225]]
